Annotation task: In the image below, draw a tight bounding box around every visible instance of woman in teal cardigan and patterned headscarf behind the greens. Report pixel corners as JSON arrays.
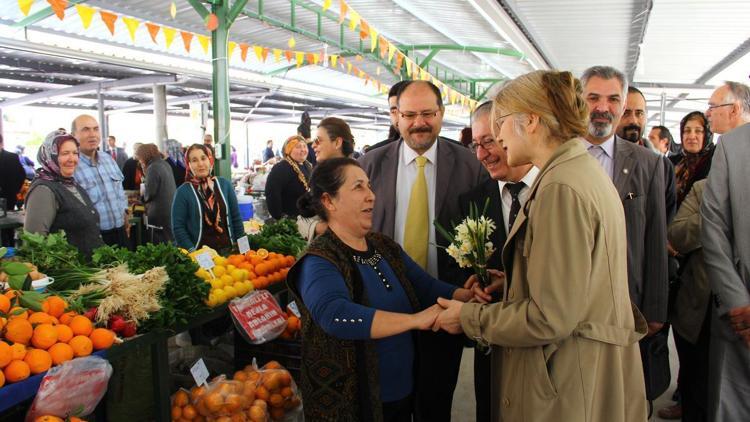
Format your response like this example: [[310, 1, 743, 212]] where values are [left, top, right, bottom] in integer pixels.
[[172, 144, 245, 251]]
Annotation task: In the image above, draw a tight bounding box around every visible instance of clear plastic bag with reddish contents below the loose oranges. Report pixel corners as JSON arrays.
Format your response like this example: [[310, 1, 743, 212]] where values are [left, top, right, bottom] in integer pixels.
[[26, 356, 112, 422]]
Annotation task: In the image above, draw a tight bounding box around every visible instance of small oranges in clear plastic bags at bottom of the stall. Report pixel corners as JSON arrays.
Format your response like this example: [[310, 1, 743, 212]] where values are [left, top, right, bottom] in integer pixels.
[[172, 362, 302, 422]]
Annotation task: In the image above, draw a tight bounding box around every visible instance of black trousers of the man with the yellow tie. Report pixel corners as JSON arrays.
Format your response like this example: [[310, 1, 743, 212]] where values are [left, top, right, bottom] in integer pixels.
[[415, 331, 464, 422]]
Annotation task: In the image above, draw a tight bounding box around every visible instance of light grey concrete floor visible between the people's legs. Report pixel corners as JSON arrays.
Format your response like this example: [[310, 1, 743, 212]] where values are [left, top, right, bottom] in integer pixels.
[[451, 335, 679, 422]]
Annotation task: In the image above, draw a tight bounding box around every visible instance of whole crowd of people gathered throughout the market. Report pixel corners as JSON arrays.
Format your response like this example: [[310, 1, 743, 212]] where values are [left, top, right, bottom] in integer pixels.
[[0, 66, 750, 422]]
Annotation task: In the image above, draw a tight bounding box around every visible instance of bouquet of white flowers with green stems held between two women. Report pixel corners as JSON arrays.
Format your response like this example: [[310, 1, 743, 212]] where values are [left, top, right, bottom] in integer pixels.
[[434, 199, 495, 288]]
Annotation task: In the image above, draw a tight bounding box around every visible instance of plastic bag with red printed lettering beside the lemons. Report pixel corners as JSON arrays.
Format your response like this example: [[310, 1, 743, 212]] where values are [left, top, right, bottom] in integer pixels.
[[229, 290, 287, 344]]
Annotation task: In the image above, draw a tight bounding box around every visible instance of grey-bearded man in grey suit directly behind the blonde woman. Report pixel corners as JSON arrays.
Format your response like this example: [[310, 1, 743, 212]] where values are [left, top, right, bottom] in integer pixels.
[[581, 66, 668, 335]]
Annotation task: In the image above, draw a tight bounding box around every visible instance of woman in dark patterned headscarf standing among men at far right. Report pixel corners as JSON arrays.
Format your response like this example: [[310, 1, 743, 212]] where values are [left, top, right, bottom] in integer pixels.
[[659, 111, 714, 421]]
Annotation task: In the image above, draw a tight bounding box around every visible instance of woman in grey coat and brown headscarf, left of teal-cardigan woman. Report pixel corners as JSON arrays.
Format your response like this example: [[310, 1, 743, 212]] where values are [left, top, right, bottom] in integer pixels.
[[135, 144, 177, 243]]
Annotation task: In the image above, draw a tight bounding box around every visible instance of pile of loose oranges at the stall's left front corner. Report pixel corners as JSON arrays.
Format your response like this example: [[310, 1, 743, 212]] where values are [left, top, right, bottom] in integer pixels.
[[0, 290, 115, 387]]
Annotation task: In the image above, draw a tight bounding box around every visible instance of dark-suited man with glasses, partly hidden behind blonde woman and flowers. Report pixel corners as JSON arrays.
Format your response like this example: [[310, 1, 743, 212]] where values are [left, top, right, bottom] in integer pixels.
[[458, 101, 539, 422]]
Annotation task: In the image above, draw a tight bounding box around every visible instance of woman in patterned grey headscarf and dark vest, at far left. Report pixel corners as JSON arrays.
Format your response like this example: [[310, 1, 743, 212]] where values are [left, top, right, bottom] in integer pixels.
[[24, 130, 104, 258]]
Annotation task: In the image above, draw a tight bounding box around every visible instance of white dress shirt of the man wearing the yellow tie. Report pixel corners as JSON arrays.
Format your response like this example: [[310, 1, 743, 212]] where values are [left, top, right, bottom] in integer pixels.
[[394, 140, 440, 278]]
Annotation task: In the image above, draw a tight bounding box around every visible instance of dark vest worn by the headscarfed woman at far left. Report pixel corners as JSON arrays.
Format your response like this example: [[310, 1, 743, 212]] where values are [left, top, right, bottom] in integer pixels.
[[29, 178, 104, 259]]
